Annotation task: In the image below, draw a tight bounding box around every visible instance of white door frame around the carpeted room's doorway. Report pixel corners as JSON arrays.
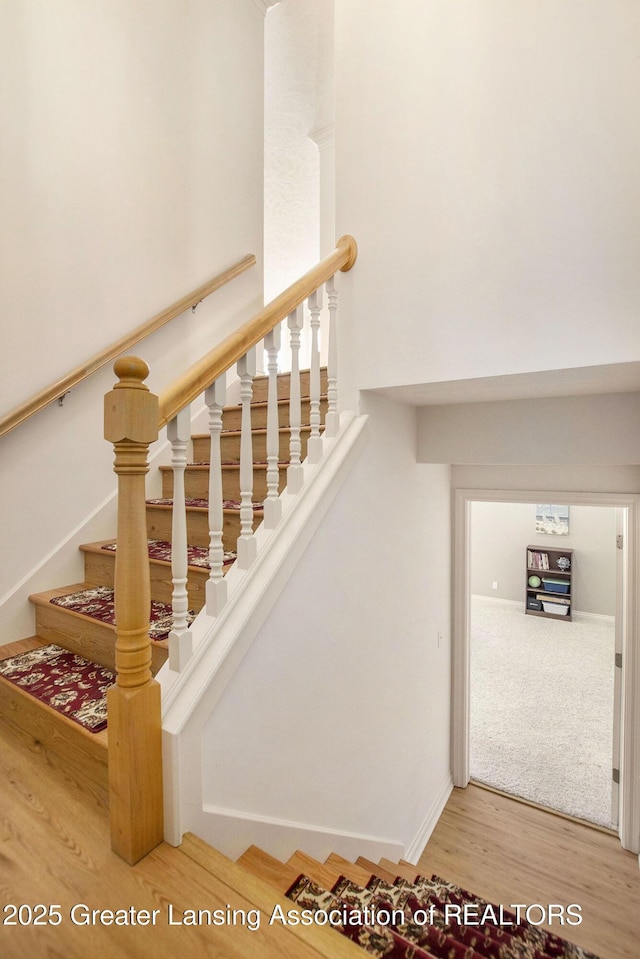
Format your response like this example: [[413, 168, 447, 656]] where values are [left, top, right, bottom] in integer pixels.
[[452, 489, 640, 853]]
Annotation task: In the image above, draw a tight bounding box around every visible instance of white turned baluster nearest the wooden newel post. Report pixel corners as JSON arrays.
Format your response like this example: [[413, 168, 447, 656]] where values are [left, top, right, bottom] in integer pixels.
[[167, 406, 193, 672]]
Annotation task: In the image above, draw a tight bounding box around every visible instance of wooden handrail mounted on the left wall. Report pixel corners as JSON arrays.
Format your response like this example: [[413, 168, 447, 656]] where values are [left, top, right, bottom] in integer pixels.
[[0, 253, 256, 436]]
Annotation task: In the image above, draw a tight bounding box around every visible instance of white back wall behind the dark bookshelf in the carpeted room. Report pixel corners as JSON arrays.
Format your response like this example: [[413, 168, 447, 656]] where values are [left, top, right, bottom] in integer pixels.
[[470, 502, 616, 616]]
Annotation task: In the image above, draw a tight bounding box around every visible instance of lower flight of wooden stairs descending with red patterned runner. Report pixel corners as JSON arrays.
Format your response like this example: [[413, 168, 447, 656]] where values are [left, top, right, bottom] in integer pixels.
[[172, 834, 597, 959]]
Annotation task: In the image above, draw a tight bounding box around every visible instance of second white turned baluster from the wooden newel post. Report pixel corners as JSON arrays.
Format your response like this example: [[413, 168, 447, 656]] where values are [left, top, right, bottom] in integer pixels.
[[204, 375, 227, 616]]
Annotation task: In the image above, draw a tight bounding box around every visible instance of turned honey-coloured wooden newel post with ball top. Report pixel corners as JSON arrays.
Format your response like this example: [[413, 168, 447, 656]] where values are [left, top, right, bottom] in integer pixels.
[[104, 356, 163, 863]]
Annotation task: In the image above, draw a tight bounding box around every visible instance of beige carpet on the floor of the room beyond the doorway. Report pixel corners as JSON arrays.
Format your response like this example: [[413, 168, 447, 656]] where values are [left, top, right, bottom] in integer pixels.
[[470, 597, 615, 826]]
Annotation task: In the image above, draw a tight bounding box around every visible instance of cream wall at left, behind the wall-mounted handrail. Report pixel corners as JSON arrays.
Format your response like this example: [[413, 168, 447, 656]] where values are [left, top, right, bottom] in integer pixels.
[[0, 0, 264, 639]]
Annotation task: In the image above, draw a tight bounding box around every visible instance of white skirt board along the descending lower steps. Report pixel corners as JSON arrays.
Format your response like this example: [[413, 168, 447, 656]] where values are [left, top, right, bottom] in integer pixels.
[[181, 805, 404, 862]]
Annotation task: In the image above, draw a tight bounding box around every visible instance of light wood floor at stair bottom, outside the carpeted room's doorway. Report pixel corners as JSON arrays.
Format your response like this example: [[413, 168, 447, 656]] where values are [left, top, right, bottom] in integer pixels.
[[418, 786, 640, 959]]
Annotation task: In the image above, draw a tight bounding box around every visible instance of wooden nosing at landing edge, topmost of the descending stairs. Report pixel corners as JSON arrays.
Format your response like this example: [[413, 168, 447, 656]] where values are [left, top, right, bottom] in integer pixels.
[[179, 833, 362, 959]]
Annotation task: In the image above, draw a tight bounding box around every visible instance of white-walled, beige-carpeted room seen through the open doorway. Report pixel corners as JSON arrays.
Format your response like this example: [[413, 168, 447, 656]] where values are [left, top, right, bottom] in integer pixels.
[[470, 502, 616, 828]]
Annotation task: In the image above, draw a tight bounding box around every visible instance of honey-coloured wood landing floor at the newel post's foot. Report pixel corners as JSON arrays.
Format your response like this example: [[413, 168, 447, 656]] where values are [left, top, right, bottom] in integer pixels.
[[0, 720, 344, 959]]
